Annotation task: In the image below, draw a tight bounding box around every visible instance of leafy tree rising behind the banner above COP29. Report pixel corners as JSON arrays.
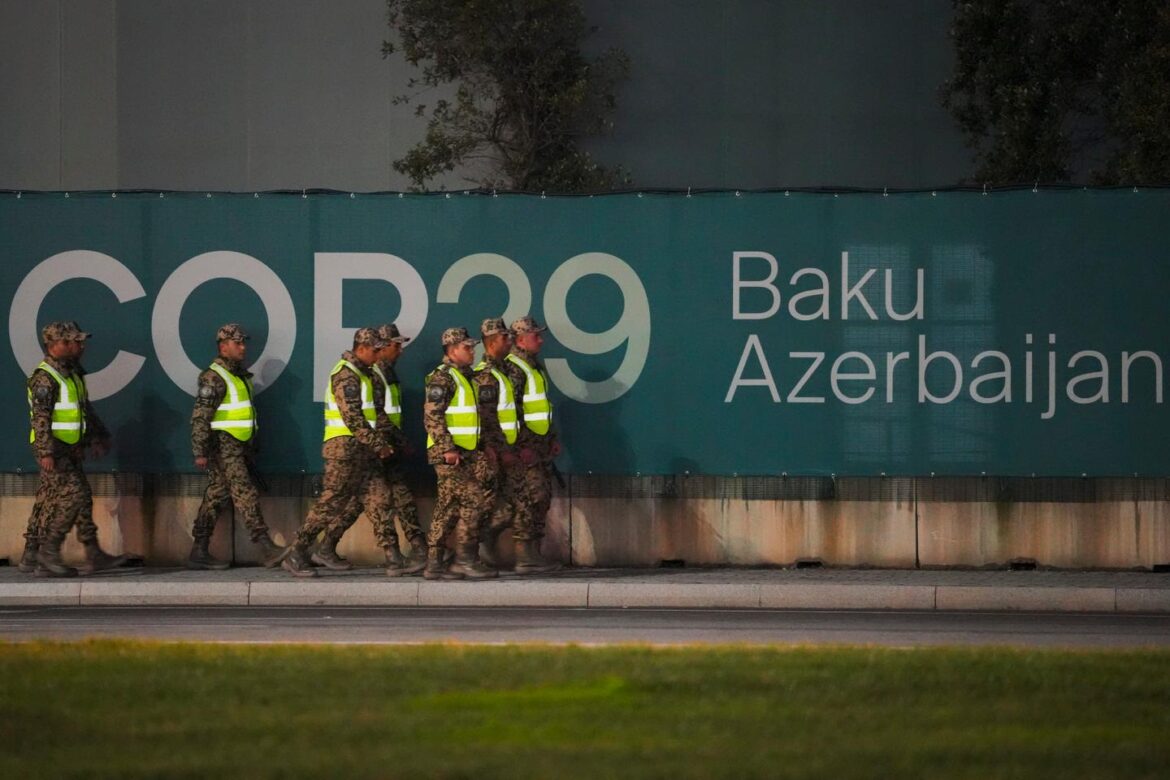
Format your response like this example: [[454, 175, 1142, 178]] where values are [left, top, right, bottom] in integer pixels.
[[383, 0, 629, 192]]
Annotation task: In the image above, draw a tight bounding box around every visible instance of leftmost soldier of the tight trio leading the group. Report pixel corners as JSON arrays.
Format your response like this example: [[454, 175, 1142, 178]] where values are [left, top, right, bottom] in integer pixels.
[[422, 327, 497, 580]]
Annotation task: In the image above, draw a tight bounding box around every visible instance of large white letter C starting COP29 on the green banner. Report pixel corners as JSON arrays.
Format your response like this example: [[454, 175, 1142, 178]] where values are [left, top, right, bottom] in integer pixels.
[[8, 249, 146, 401]]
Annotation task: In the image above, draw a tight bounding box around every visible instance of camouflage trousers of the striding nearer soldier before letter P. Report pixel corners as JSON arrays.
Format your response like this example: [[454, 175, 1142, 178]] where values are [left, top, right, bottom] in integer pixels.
[[296, 453, 397, 550]]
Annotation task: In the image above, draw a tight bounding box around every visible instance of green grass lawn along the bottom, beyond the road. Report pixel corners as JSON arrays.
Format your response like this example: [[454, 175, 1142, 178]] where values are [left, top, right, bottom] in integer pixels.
[[0, 641, 1170, 780]]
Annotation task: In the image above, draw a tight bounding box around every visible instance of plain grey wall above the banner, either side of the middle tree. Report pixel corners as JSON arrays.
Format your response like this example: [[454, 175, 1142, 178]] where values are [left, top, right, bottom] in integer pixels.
[[0, 0, 970, 192]]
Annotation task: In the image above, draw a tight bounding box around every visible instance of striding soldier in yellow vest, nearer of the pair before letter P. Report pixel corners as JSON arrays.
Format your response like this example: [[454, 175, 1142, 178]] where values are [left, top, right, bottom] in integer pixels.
[[282, 327, 397, 577]]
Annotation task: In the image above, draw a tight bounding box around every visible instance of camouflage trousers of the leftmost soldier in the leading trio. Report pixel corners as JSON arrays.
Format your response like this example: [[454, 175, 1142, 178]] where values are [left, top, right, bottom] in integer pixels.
[[427, 450, 497, 548]]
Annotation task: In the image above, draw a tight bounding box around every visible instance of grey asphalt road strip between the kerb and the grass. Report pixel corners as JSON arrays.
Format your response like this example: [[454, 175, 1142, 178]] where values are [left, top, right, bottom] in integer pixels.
[[0, 607, 1170, 648]]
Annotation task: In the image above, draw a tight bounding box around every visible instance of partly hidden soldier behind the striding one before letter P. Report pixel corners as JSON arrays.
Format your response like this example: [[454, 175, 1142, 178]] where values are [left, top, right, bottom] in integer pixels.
[[366, 324, 427, 577]]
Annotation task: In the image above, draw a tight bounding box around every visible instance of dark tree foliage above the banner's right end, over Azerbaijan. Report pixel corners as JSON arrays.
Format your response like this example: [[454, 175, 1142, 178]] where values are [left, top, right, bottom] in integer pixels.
[[942, 0, 1170, 184]]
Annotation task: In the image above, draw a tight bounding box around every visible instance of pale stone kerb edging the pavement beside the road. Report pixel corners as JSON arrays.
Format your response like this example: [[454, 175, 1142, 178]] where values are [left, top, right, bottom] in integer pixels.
[[0, 579, 1170, 613]]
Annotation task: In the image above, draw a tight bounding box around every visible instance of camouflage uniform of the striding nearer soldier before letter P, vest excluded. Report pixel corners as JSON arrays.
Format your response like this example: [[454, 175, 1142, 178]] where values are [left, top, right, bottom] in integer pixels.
[[295, 343, 391, 553]]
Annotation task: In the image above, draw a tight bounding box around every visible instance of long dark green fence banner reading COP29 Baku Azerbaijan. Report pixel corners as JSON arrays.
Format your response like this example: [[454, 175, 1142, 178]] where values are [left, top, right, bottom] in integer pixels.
[[0, 189, 1170, 476]]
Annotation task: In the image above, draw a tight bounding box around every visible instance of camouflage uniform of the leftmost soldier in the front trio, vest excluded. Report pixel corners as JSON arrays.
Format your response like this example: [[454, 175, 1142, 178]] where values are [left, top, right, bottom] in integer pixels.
[[422, 339, 498, 550]]
